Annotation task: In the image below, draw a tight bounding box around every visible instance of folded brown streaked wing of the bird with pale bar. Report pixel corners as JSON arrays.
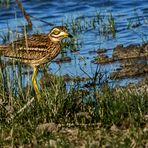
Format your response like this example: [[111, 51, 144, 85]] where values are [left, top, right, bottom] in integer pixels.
[[0, 35, 50, 60]]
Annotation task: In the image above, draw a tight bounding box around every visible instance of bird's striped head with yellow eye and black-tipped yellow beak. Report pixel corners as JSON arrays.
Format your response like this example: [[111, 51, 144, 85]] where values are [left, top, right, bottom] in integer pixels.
[[48, 26, 72, 42]]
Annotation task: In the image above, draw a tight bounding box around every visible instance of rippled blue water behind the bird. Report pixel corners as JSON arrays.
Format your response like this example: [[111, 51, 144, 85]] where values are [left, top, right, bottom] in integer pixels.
[[0, 0, 148, 86]]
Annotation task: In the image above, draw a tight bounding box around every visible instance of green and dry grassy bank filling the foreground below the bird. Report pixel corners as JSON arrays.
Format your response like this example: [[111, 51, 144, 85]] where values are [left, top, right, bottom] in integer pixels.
[[0, 70, 148, 147]]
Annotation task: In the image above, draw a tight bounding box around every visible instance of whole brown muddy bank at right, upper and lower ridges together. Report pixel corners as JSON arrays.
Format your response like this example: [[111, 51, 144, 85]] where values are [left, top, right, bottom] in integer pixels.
[[93, 44, 148, 79]]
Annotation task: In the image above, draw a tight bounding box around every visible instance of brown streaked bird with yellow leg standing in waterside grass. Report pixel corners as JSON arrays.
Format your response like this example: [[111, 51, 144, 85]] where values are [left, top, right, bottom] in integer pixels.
[[0, 26, 73, 97]]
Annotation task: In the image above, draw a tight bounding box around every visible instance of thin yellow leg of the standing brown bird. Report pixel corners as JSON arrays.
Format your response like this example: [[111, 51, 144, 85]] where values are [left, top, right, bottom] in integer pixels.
[[32, 67, 40, 97]]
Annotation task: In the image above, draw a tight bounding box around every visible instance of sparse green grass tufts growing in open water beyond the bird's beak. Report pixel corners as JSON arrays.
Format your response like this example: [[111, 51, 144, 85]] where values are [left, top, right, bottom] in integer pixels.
[[62, 12, 117, 38]]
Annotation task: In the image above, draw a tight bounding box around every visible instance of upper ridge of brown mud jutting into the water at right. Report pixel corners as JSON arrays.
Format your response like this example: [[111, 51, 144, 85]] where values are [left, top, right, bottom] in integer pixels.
[[92, 44, 148, 64]]
